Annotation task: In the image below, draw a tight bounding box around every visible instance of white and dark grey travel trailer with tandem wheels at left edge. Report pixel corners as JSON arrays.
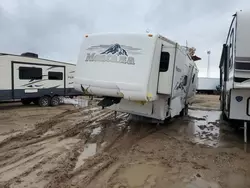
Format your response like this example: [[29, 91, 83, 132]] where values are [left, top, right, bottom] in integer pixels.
[[0, 53, 80, 106]]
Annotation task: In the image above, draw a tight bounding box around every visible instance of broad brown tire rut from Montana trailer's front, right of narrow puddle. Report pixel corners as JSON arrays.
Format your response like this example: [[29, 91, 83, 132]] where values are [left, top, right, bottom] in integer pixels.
[[52, 119, 160, 187]]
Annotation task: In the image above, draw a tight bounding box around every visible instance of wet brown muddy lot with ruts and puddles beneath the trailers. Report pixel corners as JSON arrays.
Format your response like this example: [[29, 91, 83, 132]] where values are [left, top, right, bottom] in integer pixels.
[[0, 96, 250, 188]]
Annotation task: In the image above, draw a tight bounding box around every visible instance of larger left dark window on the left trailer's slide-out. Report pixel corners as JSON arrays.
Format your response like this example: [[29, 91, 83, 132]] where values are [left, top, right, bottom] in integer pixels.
[[19, 67, 43, 80]]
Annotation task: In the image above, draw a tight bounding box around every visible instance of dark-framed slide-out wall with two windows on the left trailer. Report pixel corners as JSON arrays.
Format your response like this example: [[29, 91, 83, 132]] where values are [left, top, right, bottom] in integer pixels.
[[12, 61, 65, 99]]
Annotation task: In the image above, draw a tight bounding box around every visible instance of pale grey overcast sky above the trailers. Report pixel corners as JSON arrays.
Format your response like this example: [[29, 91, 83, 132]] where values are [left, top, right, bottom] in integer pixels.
[[0, 0, 250, 77]]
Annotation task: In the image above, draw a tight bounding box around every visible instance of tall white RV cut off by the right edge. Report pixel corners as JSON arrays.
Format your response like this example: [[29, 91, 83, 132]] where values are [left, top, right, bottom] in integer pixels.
[[219, 11, 250, 121]]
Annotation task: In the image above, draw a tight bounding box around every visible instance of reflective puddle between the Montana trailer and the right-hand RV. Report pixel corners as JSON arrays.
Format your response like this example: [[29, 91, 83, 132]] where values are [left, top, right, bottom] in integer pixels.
[[186, 110, 250, 152]]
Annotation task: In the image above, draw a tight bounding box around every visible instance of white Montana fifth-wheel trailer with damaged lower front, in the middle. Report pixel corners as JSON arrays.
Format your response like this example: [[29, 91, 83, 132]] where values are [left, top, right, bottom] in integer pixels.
[[74, 33, 198, 121]]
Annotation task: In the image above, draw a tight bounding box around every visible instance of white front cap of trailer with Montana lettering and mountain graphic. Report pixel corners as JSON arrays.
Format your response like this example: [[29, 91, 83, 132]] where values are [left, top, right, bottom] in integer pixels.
[[75, 34, 157, 101]]
